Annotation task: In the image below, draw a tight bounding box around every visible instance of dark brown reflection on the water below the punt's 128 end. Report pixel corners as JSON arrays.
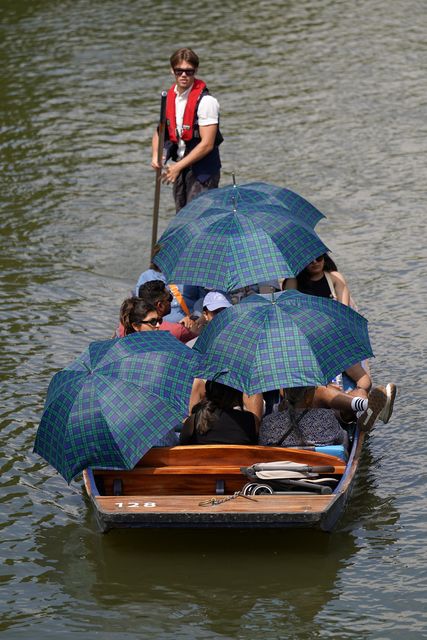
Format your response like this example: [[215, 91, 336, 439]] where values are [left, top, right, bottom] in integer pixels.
[[27, 521, 357, 637]]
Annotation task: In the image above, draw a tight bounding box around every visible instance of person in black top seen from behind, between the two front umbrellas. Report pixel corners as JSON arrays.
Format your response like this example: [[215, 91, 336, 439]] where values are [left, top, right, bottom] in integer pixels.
[[179, 380, 258, 445]]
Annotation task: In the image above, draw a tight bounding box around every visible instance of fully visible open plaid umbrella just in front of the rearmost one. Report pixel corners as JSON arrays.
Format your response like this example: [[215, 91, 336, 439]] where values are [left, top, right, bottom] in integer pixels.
[[155, 202, 328, 291]]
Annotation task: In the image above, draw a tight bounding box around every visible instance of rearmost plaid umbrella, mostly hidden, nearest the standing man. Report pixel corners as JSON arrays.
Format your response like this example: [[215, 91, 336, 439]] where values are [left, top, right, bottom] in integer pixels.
[[174, 182, 325, 228]]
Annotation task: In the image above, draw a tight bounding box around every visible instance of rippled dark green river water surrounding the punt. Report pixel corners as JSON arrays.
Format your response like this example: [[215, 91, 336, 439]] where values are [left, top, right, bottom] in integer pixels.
[[0, 0, 427, 640]]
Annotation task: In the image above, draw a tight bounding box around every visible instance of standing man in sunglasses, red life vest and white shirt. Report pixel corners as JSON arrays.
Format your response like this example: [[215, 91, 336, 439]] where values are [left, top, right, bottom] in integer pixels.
[[151, 48, 223, 212]]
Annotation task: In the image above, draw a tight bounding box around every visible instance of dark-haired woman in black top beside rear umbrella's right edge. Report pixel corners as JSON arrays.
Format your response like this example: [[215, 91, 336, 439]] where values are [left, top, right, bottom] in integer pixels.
[[282, 253, 353, 306]]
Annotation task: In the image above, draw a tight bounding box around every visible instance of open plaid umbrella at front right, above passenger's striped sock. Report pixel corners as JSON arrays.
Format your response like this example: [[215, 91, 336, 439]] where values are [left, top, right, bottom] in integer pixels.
[[194, 291, 373, 394]]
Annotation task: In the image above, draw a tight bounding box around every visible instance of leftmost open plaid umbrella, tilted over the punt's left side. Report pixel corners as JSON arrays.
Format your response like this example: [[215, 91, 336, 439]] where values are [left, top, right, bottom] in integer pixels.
[[34, 331, 200, 482]]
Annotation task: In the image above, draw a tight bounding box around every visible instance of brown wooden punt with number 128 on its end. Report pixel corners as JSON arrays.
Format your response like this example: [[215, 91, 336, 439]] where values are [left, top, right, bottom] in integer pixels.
[[83, 430, 364, 531]]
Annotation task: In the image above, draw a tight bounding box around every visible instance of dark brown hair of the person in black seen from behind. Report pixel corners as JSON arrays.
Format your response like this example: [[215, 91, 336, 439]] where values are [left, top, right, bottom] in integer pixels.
[[191, 380, 243, 434]]
